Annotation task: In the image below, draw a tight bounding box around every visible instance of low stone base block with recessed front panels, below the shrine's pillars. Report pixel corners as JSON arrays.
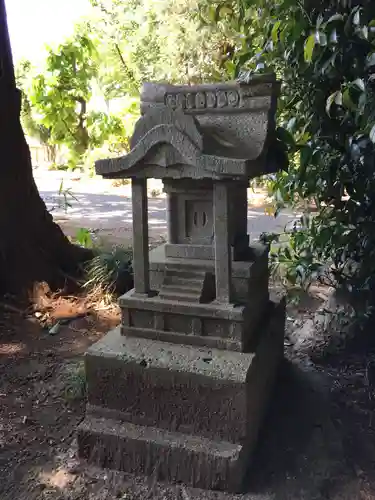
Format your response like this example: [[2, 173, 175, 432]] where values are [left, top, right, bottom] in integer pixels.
[[119, 290, 269, 352]]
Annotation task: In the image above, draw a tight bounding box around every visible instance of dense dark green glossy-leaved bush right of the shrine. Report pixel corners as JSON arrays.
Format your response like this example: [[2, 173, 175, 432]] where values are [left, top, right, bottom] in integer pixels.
[[202, 0, 375, 314]]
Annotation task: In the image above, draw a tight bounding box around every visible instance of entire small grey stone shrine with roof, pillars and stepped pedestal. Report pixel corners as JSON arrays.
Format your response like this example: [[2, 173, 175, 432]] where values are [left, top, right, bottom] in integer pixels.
[[78, 75, 285, 492]]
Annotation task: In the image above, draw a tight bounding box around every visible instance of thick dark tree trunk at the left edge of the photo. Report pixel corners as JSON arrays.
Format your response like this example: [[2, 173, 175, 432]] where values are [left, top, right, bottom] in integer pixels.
[[0, 0, 90, 294]]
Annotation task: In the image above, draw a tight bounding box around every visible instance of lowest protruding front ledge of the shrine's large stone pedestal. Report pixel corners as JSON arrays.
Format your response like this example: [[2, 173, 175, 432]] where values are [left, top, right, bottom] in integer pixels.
[[78, 416, 248, 493]]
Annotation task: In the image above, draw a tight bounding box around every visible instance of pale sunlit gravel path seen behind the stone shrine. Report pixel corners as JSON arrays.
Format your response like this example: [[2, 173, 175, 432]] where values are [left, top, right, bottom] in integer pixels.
[[34, 169, 295, 243]]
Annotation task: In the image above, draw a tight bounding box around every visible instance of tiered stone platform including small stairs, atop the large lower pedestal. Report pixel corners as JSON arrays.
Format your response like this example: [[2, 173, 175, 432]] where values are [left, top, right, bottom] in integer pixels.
[[119, 245, 269, 352]]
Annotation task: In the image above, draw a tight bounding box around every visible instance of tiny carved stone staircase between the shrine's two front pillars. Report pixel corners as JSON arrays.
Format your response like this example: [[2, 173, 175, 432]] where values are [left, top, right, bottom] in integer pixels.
[[159, 263, 215, 304]]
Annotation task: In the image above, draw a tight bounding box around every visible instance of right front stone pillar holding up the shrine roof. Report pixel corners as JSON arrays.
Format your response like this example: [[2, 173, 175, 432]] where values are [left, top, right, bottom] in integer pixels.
[[213, 181, 233, 304]]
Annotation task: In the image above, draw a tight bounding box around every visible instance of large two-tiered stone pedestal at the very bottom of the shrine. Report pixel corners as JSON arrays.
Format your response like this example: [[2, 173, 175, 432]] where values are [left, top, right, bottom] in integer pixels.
[[78, 300, 285, 492]]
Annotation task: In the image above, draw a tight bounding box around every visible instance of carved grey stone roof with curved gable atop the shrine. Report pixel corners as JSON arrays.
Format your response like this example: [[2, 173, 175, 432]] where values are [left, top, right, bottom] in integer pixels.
[[96, 77, 279, 178]]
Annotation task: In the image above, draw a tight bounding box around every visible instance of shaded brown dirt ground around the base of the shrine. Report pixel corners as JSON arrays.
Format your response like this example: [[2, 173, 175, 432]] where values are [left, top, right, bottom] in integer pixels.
[[0, 286, 375, 500]]
